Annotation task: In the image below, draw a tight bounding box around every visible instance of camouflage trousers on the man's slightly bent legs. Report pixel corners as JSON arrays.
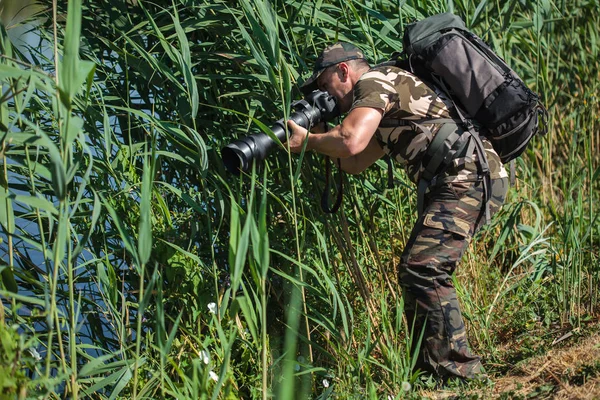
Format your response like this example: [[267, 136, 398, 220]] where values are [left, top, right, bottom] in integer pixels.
[[399, 178, 508, 379]]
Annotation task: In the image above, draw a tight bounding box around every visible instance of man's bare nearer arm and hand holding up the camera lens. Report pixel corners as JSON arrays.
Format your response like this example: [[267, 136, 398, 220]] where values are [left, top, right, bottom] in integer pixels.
[[288, 107, 383, 159]]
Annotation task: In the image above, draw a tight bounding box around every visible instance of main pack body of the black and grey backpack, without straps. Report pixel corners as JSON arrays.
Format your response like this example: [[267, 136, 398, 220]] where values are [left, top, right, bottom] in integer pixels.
[[403, 13, 548, 163]]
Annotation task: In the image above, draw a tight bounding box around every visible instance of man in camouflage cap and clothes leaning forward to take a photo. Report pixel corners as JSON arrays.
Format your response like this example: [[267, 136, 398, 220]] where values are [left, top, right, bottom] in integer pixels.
[[288, 42, 508, 379]]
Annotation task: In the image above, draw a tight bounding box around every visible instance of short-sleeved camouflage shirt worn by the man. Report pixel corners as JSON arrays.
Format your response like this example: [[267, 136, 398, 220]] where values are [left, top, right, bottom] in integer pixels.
[[352, 66, 506, 182]]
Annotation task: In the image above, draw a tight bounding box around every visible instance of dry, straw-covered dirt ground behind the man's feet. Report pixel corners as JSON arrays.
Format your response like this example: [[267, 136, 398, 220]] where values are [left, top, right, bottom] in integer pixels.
[[421, 334, 600, 400]]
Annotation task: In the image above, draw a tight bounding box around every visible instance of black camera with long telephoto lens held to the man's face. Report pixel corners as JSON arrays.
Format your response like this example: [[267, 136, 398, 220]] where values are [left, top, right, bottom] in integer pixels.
[[221, 90, 340, 175]]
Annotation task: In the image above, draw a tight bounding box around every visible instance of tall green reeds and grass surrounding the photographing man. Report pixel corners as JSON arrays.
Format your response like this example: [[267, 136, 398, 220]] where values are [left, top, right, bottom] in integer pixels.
[[0, 0, 600, 399]]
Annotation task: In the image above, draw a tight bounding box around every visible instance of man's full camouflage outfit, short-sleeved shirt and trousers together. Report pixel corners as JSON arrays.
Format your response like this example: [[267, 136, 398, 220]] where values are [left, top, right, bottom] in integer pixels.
[[352, 61, 508, 379]]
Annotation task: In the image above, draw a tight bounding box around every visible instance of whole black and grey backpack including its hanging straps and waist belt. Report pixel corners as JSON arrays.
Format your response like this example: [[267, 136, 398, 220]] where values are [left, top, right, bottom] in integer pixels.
[[392, 13, 548, 220]]
